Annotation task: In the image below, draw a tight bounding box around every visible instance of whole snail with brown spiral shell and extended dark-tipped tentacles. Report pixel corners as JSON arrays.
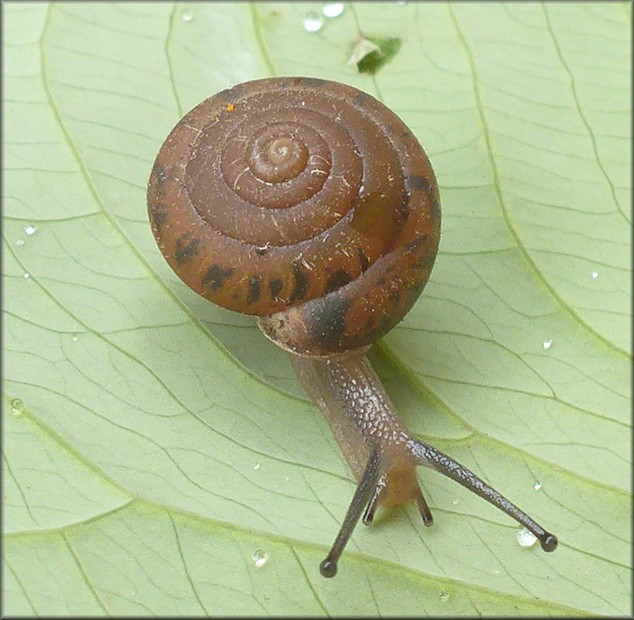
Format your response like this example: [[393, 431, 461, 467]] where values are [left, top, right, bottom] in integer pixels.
[[147, 77, 557, 577]]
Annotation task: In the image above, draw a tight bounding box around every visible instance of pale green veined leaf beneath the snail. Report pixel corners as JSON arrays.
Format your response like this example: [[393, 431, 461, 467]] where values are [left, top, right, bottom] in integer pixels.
[[3, 2, 632, 616]]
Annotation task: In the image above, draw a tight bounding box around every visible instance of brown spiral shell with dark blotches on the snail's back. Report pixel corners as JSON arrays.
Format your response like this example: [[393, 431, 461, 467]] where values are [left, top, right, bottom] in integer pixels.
[[148, 78, 440, 356]]
